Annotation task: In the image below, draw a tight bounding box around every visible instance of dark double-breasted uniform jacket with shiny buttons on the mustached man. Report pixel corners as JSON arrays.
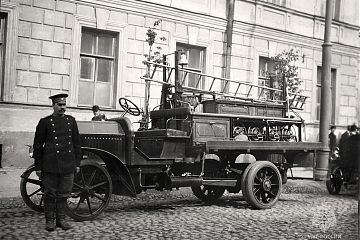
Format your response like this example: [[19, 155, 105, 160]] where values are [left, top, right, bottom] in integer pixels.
[[33, 115, 81, 174]]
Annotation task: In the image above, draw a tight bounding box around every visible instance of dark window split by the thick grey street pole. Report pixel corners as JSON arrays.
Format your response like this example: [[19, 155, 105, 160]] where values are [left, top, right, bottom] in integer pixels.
[[316, 66, 336, 124]]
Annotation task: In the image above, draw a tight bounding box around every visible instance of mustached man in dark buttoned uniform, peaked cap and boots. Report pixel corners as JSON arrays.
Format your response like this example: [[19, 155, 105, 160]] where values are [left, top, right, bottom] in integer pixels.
[[33, 93, 81, 231]]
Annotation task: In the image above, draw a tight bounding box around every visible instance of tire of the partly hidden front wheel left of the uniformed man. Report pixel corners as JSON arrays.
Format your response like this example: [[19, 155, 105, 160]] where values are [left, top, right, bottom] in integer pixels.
[[20, 164, 44, 212]]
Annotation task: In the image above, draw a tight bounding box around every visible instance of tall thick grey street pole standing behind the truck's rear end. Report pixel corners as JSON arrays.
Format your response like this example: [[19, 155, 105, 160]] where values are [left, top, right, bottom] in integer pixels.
[[314, 0, 333, 180]]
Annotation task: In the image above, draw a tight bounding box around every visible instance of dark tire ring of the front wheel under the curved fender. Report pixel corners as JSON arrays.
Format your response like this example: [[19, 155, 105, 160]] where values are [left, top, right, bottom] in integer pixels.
[[65, 160, 113, 221]]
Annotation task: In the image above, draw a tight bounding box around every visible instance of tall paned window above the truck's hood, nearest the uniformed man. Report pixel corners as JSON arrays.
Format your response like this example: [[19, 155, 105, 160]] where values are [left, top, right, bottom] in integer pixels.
[[78, 28, 117, 107]]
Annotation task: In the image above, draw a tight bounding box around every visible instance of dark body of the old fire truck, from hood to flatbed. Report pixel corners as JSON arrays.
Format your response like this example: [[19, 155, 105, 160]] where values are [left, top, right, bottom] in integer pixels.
[[79, 103, 321, 202]]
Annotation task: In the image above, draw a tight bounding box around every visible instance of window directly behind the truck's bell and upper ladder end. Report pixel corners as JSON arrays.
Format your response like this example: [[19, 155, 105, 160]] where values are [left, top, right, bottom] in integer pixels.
[[176, 43, 206, 87]]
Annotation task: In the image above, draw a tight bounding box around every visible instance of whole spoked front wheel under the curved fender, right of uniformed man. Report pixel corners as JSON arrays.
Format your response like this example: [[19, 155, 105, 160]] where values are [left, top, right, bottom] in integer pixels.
[[65, 160, 112, 221]]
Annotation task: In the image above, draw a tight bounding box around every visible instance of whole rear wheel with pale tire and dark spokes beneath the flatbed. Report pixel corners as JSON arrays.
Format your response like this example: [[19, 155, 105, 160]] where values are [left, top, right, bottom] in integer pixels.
[[243, 161, 282, 209]]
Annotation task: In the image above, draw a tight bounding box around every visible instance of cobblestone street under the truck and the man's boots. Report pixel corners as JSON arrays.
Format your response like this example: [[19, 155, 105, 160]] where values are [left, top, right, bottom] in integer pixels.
[[0, 181, 358, 240]]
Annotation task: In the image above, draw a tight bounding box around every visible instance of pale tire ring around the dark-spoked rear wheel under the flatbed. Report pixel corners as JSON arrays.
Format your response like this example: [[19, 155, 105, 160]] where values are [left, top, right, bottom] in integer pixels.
[[244, 161, 282, 209]]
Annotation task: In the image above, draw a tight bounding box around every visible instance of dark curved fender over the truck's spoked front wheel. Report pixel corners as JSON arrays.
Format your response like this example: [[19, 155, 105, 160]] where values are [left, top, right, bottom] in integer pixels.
[[81, 147, 136, 197]]
